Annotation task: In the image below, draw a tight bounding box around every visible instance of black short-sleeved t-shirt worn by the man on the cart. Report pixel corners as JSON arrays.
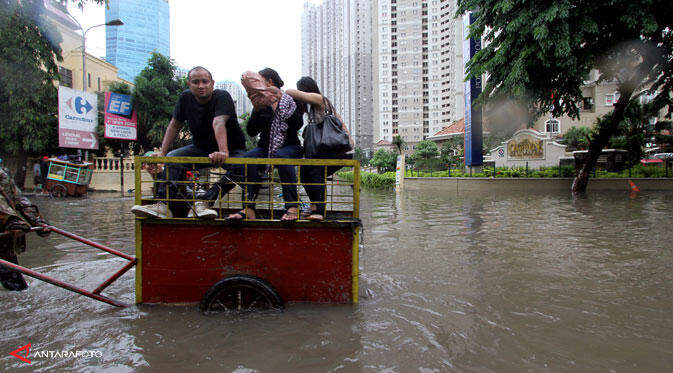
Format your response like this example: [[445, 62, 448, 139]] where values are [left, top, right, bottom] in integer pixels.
[[173, 89, 245, 152]]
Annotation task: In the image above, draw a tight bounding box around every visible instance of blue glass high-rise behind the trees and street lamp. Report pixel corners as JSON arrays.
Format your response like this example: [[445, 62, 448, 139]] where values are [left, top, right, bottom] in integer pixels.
[[105, 0, 171, 81]]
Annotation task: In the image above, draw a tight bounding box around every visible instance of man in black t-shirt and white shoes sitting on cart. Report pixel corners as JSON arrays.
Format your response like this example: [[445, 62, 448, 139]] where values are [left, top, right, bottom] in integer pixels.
[[131, 66, 245, 218]]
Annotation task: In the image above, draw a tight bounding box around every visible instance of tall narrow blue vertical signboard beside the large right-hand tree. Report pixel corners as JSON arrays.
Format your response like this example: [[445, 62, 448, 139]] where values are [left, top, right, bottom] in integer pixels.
[[463, 12, 484, 166]]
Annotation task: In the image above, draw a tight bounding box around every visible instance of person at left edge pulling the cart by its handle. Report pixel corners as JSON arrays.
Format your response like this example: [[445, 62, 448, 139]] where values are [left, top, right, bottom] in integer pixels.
[[0, 159, 49, 291]]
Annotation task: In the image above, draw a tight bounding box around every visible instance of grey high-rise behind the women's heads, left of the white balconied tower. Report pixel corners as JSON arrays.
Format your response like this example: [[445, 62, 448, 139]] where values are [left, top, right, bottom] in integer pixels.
[[301, 0, 373, 149]]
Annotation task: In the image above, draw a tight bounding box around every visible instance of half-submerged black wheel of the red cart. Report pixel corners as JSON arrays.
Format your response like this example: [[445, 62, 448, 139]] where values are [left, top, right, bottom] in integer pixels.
[[200, 275, 283, 313]]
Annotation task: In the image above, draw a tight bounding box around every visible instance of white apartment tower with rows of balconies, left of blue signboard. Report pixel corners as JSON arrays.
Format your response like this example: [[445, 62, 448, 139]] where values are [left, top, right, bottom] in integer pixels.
[[373, 0, 464, 149]]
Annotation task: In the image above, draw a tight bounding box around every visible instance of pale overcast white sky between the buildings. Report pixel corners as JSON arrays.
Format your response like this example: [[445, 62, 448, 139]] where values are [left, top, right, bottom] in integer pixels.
[[68, 0, 322, 88]]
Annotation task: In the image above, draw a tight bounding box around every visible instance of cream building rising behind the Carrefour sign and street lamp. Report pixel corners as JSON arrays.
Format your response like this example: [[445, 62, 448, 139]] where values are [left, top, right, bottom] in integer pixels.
[[44, 0, 133, 92]]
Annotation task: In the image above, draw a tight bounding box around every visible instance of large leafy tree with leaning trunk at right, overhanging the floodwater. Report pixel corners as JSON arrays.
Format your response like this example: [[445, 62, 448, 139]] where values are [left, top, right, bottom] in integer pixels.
[[457, 0, 673, 192]]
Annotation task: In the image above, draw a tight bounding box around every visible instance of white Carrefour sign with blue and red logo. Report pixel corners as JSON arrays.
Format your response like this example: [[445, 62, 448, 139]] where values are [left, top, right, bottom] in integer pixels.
[[58, 86, 98, 150]]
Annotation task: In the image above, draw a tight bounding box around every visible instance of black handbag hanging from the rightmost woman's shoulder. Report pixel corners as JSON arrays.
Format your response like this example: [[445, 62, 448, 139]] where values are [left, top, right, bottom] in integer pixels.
[[302, 98, 352, 158]]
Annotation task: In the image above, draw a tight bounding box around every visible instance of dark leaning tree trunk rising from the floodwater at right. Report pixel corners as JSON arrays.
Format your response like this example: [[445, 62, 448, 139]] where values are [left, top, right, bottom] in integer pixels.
[[572, 88, 633, 193]]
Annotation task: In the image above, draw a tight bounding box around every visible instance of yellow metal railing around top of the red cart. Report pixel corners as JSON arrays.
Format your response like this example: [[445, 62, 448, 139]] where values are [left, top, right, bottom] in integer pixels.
[[135, 157, 360, 220]]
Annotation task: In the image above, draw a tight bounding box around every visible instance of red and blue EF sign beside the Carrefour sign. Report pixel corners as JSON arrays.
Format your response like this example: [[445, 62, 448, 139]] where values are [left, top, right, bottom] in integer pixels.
[[103, 92, 138, 140]]
